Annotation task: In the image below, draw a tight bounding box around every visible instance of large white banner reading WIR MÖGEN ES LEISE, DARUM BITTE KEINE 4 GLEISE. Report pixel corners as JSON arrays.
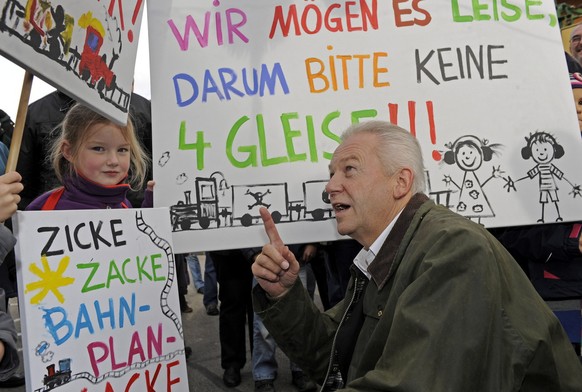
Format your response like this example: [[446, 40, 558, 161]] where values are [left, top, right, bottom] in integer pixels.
[[148, 0, 582, 252]]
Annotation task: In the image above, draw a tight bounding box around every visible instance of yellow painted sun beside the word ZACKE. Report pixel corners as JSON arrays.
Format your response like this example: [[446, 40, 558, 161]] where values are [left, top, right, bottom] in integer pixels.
[[24, 256, 75, 305]]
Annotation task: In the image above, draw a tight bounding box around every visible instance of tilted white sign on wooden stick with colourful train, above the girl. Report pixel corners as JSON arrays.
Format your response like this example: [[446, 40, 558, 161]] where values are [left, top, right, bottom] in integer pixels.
[[0, 0, 143, 124]]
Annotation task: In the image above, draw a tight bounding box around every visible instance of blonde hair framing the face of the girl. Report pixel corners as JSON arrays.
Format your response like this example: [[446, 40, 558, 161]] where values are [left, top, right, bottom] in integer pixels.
[[50, 103, 148, 190]]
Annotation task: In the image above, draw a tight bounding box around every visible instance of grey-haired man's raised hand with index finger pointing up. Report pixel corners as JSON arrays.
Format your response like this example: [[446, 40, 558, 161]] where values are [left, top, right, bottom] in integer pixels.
[[252, 207, 299, 297]]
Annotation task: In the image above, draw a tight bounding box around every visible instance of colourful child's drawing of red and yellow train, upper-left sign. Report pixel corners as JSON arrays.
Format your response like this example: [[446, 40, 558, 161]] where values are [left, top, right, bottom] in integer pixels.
[[0, 0, 131, 112]]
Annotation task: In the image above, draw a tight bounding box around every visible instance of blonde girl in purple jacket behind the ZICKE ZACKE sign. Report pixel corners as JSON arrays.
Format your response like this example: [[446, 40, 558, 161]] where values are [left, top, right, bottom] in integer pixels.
[[26, 104, 148, 210]]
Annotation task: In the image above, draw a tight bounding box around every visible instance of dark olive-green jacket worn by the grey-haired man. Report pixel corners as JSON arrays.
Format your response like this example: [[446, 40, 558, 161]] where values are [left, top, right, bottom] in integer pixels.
[[253, 194, 582, 392]]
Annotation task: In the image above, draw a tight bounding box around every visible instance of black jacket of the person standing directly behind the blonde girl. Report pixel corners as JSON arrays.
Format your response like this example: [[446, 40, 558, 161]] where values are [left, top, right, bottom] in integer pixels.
[[16, 91, 152, 209]]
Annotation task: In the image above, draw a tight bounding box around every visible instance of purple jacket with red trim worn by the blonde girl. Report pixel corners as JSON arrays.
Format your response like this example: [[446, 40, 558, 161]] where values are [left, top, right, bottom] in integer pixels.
[[26, 176, 140, 211]]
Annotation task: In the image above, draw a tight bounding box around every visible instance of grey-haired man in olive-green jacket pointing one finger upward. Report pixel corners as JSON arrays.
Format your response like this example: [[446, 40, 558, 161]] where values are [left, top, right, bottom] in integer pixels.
[[252, 121, 582, 392]]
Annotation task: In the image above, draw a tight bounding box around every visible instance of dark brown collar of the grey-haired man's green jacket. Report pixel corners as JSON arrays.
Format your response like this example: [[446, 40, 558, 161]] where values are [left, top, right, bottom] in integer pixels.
[[368, 193, 428, 289]]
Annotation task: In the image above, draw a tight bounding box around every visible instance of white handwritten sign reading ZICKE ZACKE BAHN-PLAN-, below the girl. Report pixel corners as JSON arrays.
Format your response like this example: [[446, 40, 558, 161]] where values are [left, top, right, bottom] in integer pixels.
[[15, 208, 188, 392]]
